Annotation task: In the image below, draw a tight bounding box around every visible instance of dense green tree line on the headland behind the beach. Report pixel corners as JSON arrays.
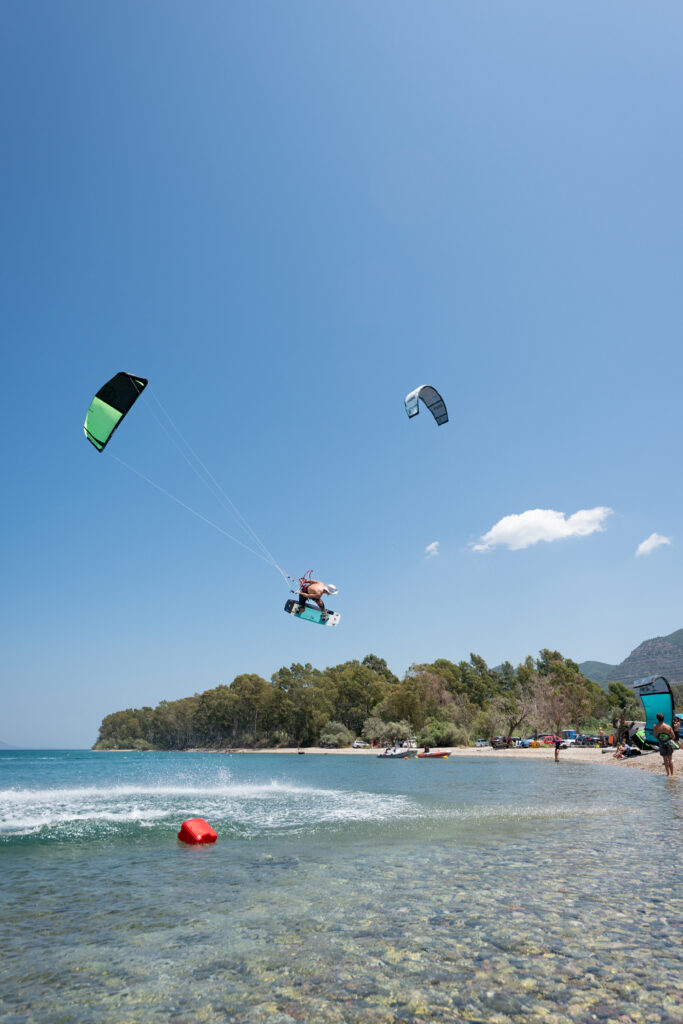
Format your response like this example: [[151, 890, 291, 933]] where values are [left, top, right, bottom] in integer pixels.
[[94, 649, 640, 751]]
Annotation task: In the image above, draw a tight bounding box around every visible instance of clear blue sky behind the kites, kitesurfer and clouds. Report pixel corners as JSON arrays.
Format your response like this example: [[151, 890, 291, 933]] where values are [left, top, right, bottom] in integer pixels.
[[0, 0, 683, 746]]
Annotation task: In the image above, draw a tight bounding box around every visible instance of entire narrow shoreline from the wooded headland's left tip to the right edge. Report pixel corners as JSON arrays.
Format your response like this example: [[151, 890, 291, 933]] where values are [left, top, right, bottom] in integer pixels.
[[93, 746, 683, 778]]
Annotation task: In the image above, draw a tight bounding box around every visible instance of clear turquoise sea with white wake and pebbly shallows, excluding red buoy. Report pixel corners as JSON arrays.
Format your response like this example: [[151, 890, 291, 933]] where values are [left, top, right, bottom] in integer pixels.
[[0, 751, 683, 1024]]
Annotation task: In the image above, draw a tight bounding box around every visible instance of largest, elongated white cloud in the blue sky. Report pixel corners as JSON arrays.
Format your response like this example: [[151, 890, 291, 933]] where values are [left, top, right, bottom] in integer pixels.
[[472, 505, 612, 551]]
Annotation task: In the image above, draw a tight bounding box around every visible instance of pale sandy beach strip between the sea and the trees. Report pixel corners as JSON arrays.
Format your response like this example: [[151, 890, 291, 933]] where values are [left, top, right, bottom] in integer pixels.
[[220, 746, 683, 777]]
